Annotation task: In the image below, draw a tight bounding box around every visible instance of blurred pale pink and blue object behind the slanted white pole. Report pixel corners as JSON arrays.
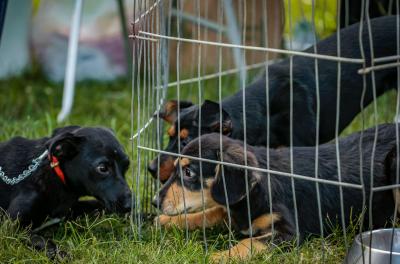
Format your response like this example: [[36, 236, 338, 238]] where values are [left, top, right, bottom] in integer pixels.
[[32, 0, 133, 81]]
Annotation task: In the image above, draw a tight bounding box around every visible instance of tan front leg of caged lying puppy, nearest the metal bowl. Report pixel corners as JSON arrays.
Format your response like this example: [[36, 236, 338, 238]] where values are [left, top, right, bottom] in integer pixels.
[[210, 233, 272, 263]]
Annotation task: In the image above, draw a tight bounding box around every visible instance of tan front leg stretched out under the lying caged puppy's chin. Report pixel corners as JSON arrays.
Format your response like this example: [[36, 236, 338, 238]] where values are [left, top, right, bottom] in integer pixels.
[[154, 206, 227, 230]]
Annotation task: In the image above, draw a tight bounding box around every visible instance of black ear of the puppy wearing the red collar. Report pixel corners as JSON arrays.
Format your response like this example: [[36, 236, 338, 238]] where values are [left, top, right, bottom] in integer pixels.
[[46, 127, 85, 160]]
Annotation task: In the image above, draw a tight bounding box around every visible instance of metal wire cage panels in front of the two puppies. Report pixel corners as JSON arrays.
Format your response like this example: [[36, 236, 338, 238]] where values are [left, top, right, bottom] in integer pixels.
[[130, 0, 400, 260]]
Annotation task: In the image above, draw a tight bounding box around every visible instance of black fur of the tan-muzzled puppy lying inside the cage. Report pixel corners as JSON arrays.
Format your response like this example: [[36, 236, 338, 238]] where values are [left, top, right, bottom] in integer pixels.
[[158, 124, 396, 241]]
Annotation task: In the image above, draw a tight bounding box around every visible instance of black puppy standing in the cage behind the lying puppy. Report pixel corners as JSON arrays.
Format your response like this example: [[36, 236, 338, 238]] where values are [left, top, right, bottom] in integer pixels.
[[148, 16, 397, 182]]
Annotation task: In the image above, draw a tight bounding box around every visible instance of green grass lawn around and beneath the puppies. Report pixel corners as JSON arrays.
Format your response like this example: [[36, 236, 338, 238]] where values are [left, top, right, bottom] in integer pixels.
[[0, 70, 396, 263]]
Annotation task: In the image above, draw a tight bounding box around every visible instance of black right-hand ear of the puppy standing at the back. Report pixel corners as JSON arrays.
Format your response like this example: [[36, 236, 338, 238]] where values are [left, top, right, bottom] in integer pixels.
[[201, 100, 232, 135]]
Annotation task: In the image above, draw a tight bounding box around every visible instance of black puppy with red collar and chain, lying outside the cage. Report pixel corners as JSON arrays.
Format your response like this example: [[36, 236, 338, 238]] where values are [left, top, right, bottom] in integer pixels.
[[0, 126, 132, 258]]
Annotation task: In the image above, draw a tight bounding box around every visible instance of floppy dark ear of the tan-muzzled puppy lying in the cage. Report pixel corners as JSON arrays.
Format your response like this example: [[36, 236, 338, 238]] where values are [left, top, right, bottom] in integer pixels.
[[211, 144, 259, 205]]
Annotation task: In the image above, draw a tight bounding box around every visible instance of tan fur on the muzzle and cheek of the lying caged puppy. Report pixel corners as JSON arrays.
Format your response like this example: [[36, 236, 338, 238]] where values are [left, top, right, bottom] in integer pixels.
[[162, 182, 218, 215]]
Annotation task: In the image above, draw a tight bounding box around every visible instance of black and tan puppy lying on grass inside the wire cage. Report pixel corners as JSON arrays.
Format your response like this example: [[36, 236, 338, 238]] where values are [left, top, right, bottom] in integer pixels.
[[153, 124, 396, 259]]
